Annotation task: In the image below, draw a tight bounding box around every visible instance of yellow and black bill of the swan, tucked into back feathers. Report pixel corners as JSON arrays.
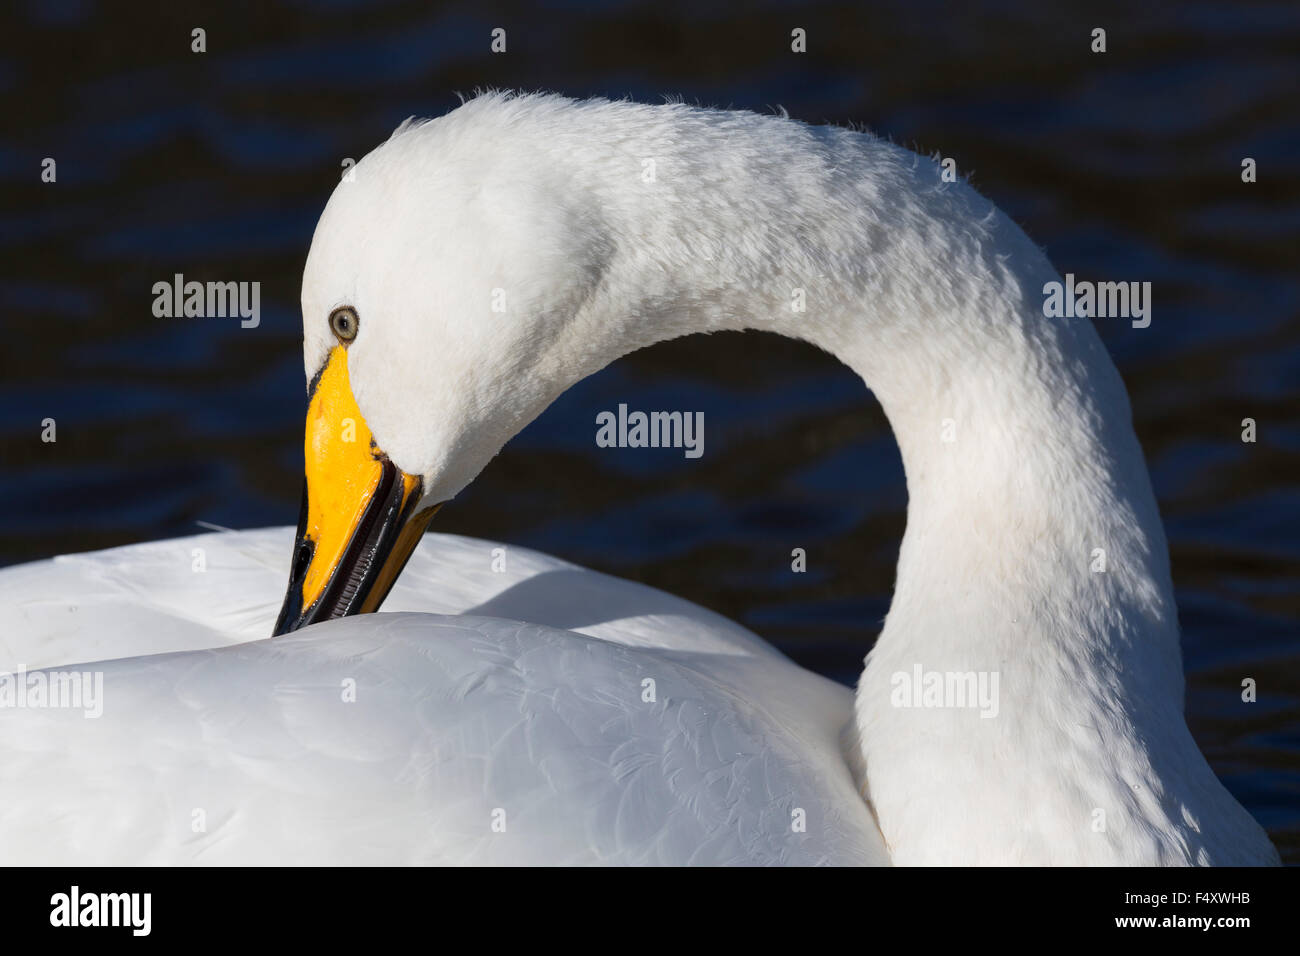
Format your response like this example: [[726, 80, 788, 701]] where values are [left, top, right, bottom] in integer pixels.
[[272, 346, 441, 636]]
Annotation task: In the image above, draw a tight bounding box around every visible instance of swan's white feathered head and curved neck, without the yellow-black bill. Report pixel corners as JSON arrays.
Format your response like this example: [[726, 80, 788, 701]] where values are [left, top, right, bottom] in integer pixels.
[[351, 96, 1275, 864]]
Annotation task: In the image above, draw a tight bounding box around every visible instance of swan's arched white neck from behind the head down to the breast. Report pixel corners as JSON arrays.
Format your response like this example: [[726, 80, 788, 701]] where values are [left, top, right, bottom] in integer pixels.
[[504, 98, 1271, 864]]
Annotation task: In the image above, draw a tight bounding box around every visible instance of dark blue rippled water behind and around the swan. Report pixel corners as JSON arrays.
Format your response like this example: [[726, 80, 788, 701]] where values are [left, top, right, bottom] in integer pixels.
[[0, 0, 1300, 862]]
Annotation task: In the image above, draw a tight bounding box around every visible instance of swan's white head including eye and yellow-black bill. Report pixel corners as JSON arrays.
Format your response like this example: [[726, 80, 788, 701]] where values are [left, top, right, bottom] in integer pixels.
[[274, 104, 619, 635]]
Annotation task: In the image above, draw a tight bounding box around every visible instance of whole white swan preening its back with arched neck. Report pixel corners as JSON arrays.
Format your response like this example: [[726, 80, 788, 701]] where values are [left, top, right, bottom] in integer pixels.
[[0, 95, 1277, 864]]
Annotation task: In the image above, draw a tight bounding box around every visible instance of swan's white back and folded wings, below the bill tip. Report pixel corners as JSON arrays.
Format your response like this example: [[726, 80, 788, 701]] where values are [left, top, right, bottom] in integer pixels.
[[0, 528, 888, 865]]
